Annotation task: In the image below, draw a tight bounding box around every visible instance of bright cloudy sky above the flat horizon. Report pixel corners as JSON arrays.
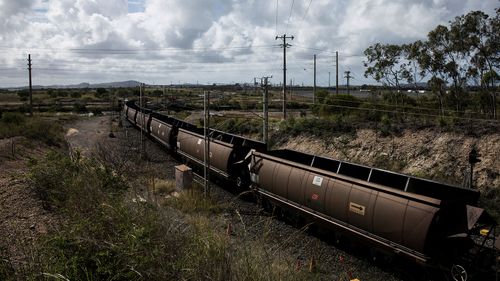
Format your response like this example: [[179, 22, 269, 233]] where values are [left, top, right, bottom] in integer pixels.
[[0, 0, 500, 87]]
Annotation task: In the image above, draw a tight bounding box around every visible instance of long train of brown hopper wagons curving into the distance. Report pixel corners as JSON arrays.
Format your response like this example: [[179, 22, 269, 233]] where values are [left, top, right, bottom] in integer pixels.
[[124, 101, 500, 281]]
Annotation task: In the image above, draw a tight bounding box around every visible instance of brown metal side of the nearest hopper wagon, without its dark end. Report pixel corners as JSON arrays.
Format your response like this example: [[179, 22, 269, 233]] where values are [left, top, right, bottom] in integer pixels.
[[249, 150, 486, 262]]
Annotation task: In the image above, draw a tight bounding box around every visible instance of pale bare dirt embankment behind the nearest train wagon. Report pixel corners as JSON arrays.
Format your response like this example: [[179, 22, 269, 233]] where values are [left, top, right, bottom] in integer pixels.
[[281, 129, 500, 190]]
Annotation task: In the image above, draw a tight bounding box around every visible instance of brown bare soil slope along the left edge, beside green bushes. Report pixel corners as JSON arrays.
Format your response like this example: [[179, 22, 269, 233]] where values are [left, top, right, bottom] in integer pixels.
[[0, 137, 59, 271]]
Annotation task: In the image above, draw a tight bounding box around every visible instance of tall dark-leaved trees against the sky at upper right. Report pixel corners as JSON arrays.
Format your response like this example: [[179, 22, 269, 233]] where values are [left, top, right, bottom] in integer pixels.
[[364, 8, 500, 118]]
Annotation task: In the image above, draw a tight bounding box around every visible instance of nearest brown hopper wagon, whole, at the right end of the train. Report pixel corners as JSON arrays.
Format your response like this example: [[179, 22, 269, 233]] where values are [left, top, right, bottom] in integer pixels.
[[247, 150, 498, 280]]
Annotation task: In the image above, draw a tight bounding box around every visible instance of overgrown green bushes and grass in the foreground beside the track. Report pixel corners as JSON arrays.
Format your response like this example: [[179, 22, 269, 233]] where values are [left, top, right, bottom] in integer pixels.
[[25, 147, 305, 280]]
